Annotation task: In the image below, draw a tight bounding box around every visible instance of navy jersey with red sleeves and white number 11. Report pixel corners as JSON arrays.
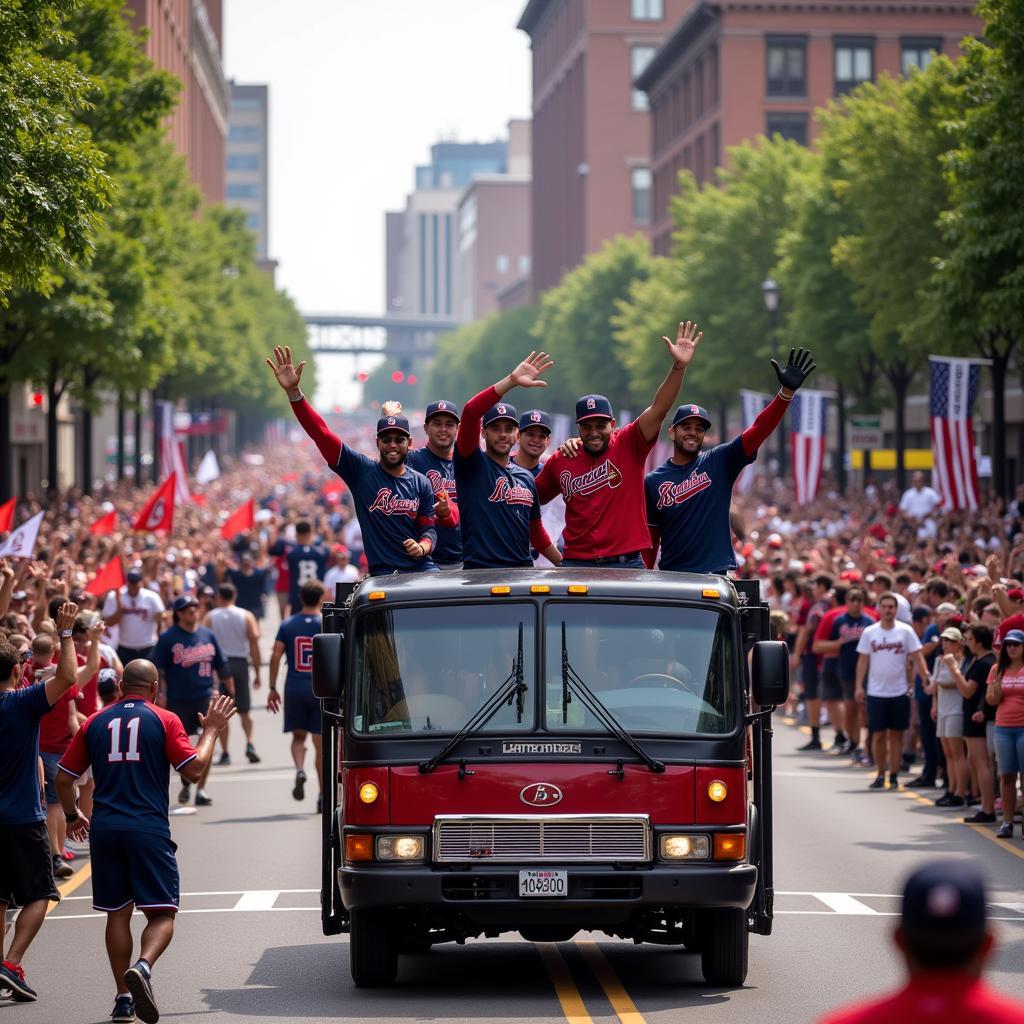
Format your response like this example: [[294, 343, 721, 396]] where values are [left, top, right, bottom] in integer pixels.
[[60, 696, 196, 839]]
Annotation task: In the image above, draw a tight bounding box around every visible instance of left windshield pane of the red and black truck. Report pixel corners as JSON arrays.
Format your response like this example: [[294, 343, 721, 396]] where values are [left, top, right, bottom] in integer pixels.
[[351, 603, 537, 734]]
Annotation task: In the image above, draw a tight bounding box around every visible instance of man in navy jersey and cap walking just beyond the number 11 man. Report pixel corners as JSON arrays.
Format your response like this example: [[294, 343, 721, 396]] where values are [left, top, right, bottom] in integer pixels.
[[153, 595, 234, 807]]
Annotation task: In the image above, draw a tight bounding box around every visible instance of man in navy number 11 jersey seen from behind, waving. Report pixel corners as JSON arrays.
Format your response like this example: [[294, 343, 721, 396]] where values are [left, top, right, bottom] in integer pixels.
[[57, 658, 234, 1024]]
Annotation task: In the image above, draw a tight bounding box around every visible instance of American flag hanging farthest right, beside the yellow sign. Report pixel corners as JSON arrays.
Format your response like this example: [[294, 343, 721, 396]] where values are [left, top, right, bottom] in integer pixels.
[[928, 355, 981, 509]]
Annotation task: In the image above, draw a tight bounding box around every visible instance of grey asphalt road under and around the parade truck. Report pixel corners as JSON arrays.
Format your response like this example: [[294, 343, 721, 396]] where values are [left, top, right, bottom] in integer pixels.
[[8, 602, 1024, 1024]]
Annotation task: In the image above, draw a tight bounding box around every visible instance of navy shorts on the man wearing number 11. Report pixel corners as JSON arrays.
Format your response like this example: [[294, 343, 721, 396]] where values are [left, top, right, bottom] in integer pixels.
[[89, 828, 179, 911]]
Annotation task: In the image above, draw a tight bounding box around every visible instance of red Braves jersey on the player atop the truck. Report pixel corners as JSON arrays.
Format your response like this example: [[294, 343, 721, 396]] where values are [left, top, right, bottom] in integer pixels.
[[537, 420, 654, 559]]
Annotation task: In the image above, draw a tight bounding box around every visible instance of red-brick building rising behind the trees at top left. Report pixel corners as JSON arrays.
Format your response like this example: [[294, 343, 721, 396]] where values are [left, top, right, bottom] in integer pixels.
[[126, 0, 230, 203]]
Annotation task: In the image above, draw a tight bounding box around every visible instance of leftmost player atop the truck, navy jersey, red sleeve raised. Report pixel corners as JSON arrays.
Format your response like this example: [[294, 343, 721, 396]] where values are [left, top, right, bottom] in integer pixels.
[[266, 345, 451, 575]]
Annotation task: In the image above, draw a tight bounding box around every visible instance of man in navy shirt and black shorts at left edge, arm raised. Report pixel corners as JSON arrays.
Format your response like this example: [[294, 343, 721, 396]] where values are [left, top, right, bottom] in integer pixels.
[[0, 603, 78, 1002]]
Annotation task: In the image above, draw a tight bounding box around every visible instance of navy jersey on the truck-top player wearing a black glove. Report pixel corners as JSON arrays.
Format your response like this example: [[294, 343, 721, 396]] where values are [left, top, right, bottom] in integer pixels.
[[644, 437, 757, 572]]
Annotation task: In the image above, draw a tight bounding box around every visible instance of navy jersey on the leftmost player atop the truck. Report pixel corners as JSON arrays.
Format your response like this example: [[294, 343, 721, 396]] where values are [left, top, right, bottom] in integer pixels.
[[333, 444, 437, 581]]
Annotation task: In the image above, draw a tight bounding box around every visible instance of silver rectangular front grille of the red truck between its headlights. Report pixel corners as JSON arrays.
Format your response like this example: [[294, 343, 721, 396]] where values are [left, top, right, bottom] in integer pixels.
[[434, 814, 651, 864]]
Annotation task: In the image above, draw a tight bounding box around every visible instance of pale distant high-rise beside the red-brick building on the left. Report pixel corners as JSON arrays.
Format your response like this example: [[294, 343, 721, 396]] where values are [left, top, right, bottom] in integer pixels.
[[225, 82, 270, 261]]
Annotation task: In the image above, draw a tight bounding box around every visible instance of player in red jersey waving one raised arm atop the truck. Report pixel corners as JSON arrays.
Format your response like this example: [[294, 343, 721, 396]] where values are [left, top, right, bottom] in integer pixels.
[[537, 321, 703, 569]]
